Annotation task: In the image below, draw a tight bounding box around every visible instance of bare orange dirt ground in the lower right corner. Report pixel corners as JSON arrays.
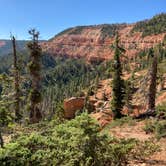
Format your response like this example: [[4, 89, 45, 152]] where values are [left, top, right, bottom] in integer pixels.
[[110, 121, 166, 166]]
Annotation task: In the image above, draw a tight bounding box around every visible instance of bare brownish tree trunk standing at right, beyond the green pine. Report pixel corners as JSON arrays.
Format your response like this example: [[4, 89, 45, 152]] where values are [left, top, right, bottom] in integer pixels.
[[148, 48, 158, 111]]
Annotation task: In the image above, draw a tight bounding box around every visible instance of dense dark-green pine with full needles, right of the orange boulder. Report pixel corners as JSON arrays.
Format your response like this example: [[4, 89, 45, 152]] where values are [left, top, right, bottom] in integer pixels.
[[111, 35, 125, 119]]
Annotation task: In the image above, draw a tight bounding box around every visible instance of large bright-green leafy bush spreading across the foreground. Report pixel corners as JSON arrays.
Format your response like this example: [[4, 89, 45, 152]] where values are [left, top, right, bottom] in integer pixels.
[[0, 113, 158, 166]]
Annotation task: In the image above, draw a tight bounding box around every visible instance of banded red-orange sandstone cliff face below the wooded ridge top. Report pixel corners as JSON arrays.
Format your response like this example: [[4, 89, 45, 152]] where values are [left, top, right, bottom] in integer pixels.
[[41, 24, 166, 61]]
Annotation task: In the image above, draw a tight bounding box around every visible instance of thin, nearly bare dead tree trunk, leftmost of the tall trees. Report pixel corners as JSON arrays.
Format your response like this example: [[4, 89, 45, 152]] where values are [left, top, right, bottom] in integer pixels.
[[12, 36, 21, 122]]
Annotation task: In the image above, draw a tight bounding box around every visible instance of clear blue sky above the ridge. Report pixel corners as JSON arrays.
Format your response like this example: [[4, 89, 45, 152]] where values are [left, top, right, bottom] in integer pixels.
[[0, 0, 166, 39]]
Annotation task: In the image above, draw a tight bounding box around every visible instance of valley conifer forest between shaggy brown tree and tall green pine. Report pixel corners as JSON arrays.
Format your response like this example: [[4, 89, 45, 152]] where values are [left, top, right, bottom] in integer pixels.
[[43, 58, 110, 114]]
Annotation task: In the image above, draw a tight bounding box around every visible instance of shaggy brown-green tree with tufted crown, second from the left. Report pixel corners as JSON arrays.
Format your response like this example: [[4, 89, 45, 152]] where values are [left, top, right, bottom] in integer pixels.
[[28, 29, 42, 123]]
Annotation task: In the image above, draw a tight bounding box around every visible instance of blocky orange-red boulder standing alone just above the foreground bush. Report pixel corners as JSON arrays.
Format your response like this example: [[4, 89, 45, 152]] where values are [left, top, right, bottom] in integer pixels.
[[64, 97, 85, 119]]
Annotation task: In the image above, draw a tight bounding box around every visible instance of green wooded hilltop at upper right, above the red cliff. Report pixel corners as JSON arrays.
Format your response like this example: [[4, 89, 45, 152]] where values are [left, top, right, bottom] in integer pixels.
[[132, 13, 166, 37]]
